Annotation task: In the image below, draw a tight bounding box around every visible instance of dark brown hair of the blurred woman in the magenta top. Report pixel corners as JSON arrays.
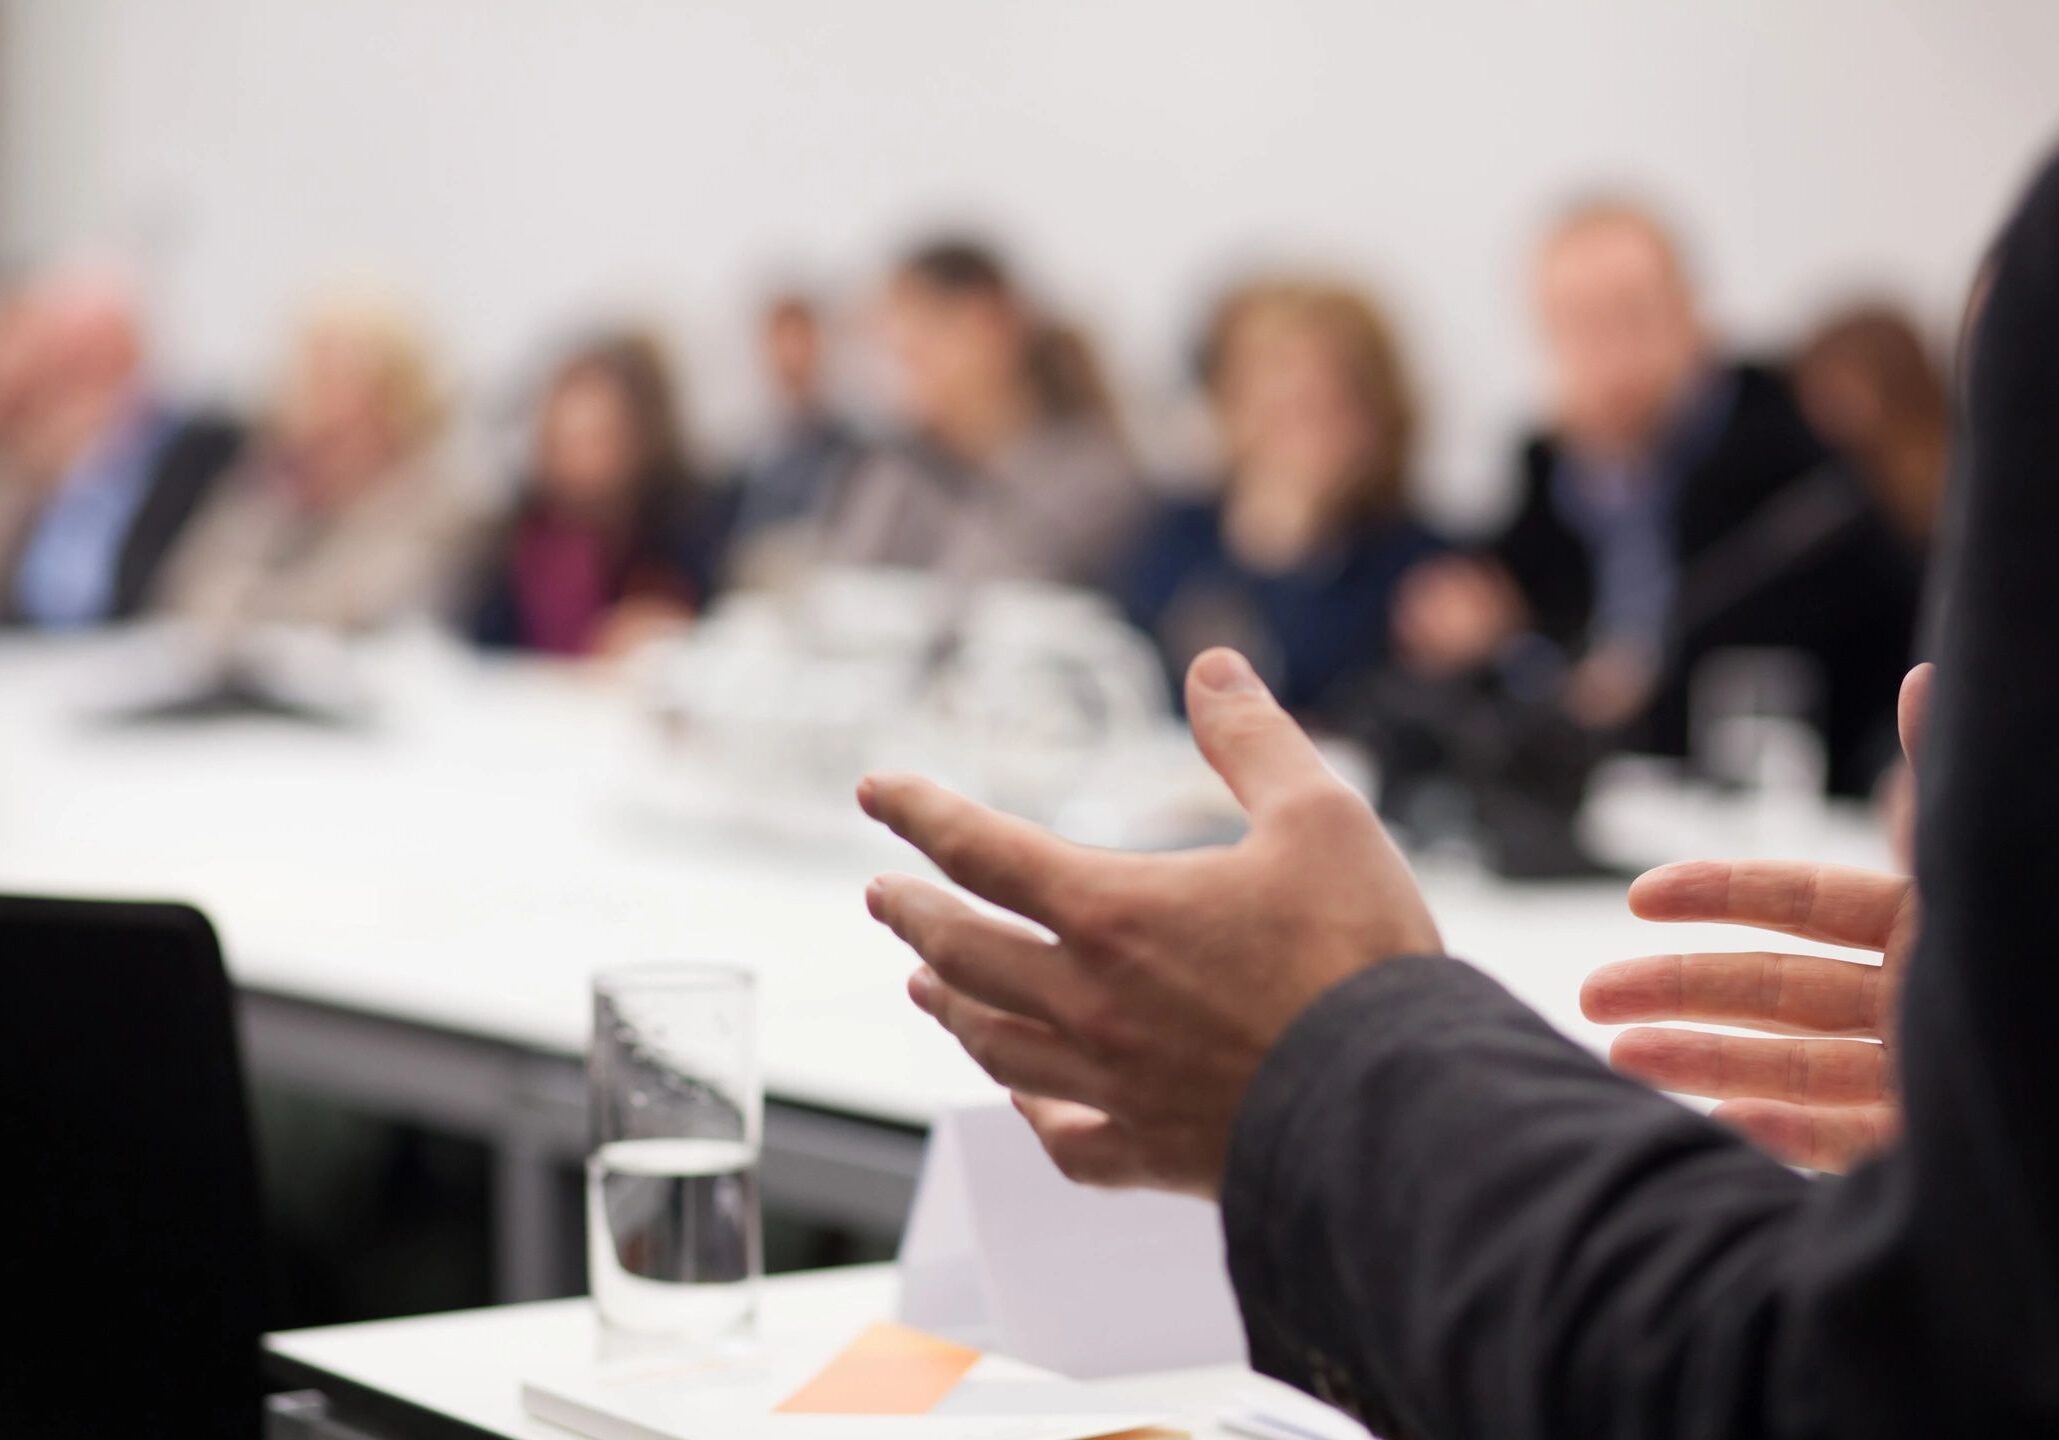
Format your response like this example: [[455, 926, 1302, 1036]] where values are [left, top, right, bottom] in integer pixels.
[[523, 330, 696, 552]]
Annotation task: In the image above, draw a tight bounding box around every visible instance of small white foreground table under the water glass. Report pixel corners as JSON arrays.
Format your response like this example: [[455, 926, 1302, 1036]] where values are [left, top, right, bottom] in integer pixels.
[[266, 1265, 1334, 1440]]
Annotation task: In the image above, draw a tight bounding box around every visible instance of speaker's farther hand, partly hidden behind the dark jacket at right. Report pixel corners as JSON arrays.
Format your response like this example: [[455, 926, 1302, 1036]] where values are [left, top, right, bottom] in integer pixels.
[[1579, 665, 1931, 1170]]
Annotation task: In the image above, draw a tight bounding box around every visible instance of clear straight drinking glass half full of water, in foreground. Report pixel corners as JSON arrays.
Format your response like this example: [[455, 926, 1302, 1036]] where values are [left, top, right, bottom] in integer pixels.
[[587, 964, 764, 1343]]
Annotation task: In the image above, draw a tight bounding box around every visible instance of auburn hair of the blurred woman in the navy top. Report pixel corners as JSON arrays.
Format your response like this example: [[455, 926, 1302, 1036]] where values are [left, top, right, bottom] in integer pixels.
[[1198, 276, 1421, 517]]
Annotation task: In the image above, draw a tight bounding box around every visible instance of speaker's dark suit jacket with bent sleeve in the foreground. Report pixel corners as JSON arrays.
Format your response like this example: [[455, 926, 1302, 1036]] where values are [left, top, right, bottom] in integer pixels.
[[1223, 146, 2059, 1440]]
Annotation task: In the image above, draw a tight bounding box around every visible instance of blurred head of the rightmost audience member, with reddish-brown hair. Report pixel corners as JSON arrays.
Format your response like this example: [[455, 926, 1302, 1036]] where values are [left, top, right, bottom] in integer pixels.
[[1793, 301, 1952, 536]]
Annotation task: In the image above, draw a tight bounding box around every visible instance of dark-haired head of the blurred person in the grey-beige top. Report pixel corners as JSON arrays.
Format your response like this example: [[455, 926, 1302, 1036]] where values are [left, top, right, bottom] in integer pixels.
[[883, 239, 1038, 451]]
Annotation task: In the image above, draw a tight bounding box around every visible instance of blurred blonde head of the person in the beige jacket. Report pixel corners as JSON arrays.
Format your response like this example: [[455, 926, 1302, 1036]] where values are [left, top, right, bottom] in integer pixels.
[[270, 293, 445, 505]]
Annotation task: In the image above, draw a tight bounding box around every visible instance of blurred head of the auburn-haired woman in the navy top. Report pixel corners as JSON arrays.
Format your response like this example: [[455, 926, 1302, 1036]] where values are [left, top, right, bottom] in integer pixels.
[[1202, 278, 1417, 521]]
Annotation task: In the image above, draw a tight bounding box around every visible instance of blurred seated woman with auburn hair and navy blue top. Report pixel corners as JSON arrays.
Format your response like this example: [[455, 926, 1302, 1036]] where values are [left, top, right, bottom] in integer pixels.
[[1118, 278, 1437, 715]]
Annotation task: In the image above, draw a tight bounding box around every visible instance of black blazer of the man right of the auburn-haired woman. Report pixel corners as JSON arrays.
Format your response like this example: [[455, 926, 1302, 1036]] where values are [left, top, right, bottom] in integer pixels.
[[1493, 365, 1921, 791]]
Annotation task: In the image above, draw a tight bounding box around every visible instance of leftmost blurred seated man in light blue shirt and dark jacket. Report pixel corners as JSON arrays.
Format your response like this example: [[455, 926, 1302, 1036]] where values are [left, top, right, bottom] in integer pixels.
[[0, 268, 241, 628]]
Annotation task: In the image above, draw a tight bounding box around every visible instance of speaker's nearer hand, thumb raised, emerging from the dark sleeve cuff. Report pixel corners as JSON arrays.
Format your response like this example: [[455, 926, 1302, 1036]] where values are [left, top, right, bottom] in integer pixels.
[[859, 649, 1439, 1197]]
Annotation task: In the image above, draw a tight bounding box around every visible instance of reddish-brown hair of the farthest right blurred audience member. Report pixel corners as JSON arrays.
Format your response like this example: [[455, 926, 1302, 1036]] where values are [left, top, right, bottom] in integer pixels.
[[1791, 301, 1952, 534]]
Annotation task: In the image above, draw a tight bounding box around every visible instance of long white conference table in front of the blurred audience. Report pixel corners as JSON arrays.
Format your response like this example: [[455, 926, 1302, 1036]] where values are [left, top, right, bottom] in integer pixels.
[[0, 637, 1882, 1300]]
